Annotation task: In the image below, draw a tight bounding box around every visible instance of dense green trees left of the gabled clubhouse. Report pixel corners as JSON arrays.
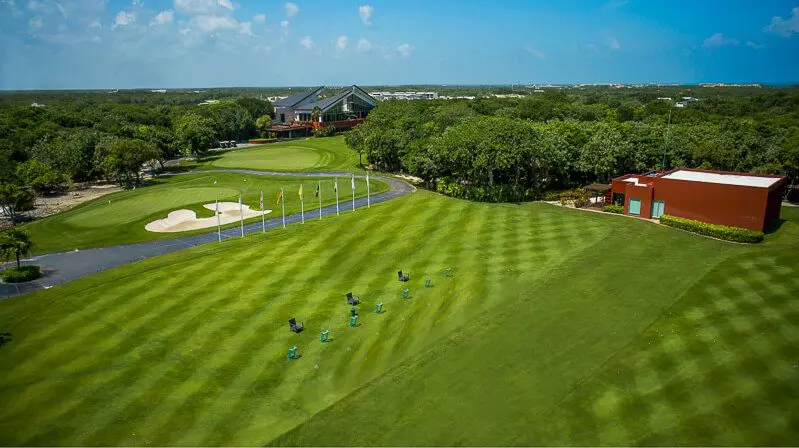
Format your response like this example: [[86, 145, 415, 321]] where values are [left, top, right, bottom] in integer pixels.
[[0, 92, 274, 222]]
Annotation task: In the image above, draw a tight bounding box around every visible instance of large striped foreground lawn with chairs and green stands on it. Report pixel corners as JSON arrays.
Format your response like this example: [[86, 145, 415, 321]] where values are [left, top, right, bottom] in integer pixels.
[[0, 191, 799, 446]]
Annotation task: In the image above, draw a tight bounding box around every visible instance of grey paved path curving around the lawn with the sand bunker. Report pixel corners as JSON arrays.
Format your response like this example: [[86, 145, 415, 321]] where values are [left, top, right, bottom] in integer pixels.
[[0, 169, 415, 299]]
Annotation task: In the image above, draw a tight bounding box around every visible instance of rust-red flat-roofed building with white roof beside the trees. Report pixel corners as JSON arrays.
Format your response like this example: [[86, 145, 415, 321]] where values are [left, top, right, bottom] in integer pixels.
[[605, 168, 786, 231]]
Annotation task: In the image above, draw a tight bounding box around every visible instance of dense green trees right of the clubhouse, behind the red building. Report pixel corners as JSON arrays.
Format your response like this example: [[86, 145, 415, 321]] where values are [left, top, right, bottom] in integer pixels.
[[346, 89, 799, 201]]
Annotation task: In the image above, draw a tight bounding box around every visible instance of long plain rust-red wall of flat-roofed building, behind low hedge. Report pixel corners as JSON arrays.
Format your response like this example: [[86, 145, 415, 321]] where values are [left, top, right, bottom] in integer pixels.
[[654, 178, 769, 231]]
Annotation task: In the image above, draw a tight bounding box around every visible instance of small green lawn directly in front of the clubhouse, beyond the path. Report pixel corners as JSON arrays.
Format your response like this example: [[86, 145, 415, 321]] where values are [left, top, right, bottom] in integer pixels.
[[181, 135, 363, 172]]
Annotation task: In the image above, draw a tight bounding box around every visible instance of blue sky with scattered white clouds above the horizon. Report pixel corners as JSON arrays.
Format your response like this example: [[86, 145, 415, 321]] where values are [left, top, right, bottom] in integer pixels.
[[0, 0, 799, 89]]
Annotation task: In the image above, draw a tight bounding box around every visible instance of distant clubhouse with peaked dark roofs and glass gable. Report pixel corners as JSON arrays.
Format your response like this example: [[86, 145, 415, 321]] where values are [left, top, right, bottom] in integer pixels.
[[269, 85, 377, 138]]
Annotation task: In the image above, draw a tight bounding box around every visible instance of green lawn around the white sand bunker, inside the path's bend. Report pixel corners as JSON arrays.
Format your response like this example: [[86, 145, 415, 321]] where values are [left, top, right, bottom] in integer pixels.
[[24, 172, 388, 253]]
